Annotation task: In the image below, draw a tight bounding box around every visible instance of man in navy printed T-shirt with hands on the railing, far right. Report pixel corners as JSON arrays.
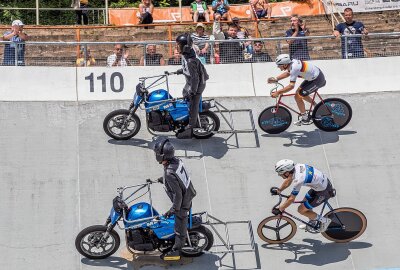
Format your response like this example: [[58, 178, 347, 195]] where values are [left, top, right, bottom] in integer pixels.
[[333, 8, 368, 59]]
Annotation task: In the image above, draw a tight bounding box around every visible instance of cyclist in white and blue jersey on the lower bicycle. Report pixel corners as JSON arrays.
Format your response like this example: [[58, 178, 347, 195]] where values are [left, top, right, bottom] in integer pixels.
[[271, 159, 334, 232]]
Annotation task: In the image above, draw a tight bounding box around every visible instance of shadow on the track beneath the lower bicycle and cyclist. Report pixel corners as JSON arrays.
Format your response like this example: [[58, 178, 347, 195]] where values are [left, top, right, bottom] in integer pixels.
[[262, 239, 372, 266]]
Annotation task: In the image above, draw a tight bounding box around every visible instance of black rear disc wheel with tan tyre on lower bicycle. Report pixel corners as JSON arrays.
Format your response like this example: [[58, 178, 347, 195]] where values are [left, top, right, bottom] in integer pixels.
[[321, 207, 367, 243]]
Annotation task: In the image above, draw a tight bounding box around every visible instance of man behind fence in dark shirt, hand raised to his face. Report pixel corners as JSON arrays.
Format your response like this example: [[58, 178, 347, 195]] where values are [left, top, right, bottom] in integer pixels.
[[286, 15, 310, 60]]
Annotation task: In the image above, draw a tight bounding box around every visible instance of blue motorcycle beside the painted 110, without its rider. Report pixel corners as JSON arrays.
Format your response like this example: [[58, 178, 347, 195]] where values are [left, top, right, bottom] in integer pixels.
[[103, 72, 220, 140]]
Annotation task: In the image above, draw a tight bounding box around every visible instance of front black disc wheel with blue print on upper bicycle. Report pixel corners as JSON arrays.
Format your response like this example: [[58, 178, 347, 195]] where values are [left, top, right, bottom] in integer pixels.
[[258, 106, 292, 134]]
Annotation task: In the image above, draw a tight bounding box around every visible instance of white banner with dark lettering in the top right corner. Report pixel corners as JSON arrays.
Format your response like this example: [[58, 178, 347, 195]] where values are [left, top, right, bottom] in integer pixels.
[[323, 0, 400, 13]]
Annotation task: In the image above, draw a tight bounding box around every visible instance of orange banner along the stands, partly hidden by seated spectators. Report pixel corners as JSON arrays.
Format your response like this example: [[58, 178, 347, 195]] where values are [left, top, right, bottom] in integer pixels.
[[109, 0, 324, 25]]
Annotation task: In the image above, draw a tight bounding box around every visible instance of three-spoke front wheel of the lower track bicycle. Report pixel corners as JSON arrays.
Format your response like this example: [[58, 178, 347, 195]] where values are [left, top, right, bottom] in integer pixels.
[[257, 216, 297, 244]]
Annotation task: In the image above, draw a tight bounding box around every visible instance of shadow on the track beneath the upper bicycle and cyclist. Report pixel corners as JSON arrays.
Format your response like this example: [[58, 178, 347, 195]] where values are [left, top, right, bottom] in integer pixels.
[[262, 129, 357, 148]]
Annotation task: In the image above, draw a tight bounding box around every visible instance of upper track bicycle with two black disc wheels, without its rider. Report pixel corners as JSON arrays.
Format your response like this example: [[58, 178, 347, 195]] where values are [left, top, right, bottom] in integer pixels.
[[258, 83, 353, 134]]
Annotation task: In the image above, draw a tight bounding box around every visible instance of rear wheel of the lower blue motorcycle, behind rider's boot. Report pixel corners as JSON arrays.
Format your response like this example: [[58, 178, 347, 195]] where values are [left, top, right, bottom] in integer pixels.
[[182, 226, 214, 257]]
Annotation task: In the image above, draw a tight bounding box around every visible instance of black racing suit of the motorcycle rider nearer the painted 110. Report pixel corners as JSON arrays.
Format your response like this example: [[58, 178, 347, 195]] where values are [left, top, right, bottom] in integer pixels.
[[178, 49, 209, 127]]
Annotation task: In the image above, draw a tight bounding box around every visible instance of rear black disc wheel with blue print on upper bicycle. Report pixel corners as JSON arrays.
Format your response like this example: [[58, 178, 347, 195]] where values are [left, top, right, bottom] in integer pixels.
[[312, 98, 353, 132]]
